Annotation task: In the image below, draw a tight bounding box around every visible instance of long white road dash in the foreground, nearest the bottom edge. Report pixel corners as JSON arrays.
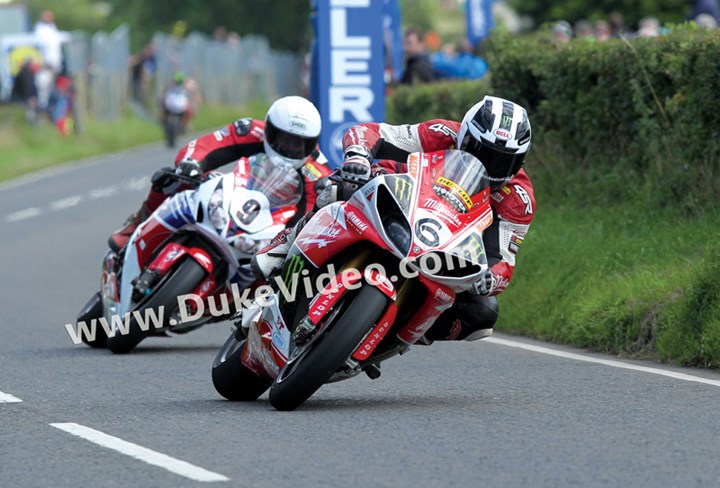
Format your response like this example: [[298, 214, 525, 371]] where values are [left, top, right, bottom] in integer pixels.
[[50, 422, 230, 481]]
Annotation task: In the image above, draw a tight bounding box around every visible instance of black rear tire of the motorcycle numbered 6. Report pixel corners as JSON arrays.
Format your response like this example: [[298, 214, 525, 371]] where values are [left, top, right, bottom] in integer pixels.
[[212, 334, 272, 402]]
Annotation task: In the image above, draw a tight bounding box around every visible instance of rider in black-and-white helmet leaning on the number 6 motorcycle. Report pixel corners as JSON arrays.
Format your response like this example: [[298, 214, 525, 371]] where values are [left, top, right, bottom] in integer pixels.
[[252, 96, 535, 344]]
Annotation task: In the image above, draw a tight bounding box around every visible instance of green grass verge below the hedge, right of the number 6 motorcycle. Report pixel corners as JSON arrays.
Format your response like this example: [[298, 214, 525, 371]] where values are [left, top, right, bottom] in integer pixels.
[[498, 181, 720, 367]]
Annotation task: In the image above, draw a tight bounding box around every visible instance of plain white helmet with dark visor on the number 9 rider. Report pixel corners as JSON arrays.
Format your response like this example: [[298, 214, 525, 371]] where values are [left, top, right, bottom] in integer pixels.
[[263, 96, 322, 168]]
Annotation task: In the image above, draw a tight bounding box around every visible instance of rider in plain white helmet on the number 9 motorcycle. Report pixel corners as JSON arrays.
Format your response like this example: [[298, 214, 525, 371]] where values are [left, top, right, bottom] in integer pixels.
[[108, 96, 331, 252]]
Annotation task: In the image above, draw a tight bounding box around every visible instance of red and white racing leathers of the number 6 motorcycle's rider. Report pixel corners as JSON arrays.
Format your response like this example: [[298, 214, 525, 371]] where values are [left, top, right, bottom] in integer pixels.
[[343, 119, 535, 341]]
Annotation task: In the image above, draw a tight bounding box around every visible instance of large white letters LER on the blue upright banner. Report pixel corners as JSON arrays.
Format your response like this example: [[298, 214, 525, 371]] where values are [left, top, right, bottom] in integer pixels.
[[329, 0, 375, 123]]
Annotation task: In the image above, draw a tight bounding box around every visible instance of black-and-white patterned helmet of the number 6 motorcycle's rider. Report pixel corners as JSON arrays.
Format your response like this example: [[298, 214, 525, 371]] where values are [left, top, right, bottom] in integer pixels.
[[458, 96, 532, 191]]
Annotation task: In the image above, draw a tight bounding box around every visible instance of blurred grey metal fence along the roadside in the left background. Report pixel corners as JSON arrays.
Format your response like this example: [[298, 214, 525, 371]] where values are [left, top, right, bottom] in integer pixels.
[[65, 26, 303, 124]]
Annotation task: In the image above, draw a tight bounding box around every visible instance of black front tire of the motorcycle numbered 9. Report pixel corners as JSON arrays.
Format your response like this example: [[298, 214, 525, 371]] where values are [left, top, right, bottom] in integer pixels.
[[107, 258, 206, 354]]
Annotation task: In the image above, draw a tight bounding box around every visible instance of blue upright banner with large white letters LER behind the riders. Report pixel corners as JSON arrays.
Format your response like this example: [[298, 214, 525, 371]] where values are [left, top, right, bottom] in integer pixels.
[[315, 0, 385, 167]]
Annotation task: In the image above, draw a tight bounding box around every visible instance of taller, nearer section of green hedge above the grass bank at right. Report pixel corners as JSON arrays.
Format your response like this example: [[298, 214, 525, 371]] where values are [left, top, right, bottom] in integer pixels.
[[489, 26, 720, 211]]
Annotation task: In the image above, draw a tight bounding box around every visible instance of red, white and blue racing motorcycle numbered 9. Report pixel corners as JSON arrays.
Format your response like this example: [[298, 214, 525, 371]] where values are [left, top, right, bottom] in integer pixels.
[[78, 154, 303, 353]]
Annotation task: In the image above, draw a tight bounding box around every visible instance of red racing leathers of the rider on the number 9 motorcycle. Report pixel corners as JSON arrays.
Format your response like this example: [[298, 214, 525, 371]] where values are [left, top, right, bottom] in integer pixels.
[[108, 118, 331, 251]]
